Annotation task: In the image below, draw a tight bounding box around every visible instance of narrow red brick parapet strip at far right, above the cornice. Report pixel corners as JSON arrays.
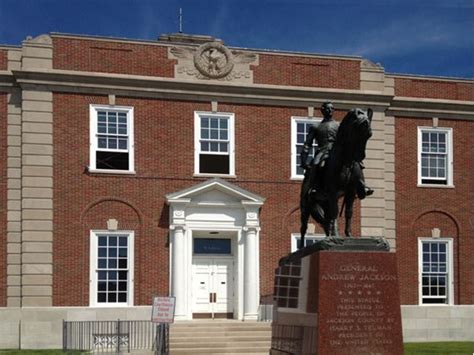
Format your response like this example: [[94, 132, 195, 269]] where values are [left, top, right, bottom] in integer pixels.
[[395, 78, 474, 101]]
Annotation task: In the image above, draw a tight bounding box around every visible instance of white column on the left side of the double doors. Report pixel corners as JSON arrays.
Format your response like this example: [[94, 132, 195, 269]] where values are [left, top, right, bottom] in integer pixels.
[[170, 225, 187, 319]]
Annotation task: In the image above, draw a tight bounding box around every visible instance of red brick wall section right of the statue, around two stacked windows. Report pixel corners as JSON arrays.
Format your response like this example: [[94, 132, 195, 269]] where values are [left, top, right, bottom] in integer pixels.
[[395, 117, 474, 304]]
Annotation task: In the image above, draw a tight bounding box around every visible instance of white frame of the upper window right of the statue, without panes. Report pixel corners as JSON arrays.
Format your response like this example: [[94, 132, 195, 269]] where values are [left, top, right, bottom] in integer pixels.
[[418, 127, 454, 188]]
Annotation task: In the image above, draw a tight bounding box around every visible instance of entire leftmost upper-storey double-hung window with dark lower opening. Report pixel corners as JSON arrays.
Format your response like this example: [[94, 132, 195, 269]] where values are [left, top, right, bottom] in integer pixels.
[[90, 105, 134, 172]]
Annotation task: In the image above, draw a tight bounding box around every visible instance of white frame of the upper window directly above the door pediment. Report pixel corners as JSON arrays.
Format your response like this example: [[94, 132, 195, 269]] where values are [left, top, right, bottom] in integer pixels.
[[194, 111, 235, 177]]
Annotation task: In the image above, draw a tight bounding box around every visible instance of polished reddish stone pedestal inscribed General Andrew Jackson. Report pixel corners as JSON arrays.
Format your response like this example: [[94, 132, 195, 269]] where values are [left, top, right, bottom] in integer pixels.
[[271, 238, 403, 355]]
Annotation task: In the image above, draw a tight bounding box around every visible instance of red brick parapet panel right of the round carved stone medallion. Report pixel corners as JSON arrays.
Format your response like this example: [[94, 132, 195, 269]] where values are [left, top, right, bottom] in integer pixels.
[[253, 54, 360, 90]]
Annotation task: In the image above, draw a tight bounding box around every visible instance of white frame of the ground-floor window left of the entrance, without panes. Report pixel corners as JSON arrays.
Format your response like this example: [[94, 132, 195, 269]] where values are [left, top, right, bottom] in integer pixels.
[[89, 230, 135, 307]]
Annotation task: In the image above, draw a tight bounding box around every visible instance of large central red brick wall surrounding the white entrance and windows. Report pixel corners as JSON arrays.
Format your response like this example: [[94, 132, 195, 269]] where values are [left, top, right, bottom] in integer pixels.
[[53, 94, 360, 306]]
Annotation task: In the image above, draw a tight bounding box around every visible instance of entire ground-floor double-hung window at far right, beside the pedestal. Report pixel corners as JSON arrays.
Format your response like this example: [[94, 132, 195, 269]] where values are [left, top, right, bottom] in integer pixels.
[[418, 239, 454, 304]]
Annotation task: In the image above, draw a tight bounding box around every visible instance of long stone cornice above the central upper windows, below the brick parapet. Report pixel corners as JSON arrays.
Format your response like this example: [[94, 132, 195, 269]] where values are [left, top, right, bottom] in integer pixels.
[[13, 69, 392, 109]]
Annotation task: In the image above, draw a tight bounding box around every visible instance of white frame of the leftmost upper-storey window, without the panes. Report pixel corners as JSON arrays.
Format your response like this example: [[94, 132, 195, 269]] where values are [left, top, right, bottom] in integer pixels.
[[89, 104, 135, 174]]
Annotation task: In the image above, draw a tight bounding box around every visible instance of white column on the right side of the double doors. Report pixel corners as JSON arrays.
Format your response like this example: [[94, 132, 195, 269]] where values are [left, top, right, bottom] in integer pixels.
[[244, 227, 260, 320]]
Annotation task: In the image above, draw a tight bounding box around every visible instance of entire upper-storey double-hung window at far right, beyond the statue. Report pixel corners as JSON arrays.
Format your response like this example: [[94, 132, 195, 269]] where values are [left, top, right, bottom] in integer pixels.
[[418, 127, 453, 186]]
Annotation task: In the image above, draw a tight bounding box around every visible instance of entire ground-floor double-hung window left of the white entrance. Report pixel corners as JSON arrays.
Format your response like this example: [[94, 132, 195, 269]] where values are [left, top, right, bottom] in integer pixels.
[[90, 231, 134, 306]]
